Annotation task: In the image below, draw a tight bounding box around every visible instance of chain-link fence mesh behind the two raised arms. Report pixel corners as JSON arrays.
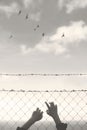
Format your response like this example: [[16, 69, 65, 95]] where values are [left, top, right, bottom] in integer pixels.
[[0, 90, 87, 130]]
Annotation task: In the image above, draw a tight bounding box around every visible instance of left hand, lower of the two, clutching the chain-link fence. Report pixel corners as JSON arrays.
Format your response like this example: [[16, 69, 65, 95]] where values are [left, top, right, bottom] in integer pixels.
[[31, 108, 43, 122]]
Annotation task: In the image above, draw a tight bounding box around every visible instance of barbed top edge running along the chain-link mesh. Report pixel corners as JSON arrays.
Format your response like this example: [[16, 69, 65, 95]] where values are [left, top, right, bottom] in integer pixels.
[[0, 89, 87, 92]]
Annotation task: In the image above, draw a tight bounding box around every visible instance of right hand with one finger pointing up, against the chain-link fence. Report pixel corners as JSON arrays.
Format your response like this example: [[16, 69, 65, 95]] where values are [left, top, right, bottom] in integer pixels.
[[45, 102, 57, 118]]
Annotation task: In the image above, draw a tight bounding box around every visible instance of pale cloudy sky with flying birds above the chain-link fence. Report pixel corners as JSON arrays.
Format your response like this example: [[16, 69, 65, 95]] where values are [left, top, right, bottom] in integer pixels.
[[0, 0, 87, 90]]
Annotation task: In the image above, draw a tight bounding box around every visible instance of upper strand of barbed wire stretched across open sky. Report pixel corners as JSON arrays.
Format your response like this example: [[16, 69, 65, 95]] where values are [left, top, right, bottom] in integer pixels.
[[0, 73, 87, 77]]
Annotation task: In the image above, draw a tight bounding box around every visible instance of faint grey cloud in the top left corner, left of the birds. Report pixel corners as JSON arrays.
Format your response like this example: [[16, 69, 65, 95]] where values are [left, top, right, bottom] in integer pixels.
[[0, 2, 18, 18]]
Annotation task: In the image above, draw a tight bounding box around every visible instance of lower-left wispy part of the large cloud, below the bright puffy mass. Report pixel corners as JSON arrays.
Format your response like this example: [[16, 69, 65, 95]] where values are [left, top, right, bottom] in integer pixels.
[[20, 36, 66, 55]]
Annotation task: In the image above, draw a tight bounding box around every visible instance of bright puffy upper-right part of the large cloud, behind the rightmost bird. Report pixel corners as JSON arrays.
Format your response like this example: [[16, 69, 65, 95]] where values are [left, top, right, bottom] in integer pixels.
[[50, 21, 87, 45]]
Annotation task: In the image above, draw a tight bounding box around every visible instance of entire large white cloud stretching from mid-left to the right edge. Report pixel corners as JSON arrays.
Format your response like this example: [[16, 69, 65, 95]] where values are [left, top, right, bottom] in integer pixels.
[[21, 21, 87, 55]]
